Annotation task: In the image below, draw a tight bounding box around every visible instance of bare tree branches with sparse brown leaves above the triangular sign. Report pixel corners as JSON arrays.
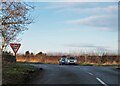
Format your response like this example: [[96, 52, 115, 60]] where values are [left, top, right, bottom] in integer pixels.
[[0, 2, 32, 51]]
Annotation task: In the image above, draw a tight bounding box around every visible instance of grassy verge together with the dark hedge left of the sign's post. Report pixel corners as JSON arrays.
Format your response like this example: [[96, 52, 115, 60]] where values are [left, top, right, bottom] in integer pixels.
[[2, 52, 42, 86]]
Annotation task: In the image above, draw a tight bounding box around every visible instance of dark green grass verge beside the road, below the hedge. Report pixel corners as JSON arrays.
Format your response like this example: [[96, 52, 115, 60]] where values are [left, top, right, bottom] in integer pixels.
[[2, 63, 42, 85]]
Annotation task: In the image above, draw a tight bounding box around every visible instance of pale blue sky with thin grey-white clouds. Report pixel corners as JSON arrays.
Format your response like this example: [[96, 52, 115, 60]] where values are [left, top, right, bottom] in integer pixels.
[[10, 2, 118, 53]]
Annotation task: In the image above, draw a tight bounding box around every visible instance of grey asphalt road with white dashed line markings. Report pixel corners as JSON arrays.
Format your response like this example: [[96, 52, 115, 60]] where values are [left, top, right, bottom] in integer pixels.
[[28, 64, 120, 86]]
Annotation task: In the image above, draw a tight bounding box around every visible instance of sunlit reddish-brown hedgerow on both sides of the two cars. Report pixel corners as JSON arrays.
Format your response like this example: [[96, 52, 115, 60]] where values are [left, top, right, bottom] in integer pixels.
[[17, 55, 120, 65]]
